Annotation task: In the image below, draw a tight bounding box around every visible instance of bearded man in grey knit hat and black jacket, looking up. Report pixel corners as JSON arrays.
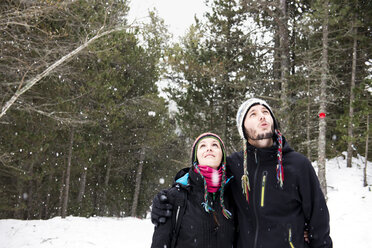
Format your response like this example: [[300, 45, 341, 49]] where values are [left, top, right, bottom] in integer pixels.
[[152, 98, 332, 248]]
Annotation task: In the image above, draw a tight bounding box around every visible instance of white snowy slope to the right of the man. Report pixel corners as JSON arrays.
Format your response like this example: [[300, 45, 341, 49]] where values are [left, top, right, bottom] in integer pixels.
[[327, 154, 372, 248]]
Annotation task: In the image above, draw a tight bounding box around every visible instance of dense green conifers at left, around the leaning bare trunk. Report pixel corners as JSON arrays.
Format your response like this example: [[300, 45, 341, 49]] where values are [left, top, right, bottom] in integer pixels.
[[0, 0, 178, 219]]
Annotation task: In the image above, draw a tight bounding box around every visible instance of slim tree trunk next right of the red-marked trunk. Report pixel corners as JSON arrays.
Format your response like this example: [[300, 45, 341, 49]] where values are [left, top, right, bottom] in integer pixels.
[[346, 20, 358, 168]]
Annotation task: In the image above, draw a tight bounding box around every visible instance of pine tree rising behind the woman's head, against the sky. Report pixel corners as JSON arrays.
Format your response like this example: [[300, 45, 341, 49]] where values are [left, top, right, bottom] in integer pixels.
[[168, 0, 263, 149]]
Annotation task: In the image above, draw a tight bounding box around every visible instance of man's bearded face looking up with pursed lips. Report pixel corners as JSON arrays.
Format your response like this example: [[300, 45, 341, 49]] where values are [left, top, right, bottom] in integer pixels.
[[244, 105, 274, 144]]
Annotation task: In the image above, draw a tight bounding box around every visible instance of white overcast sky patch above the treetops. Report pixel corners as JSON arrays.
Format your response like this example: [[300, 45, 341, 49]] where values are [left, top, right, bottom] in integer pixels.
[[129, 0, 206, 38]]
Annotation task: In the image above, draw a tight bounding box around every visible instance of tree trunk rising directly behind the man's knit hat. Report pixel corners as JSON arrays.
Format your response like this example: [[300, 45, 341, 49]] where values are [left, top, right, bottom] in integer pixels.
[[279, 0, 290, 136]]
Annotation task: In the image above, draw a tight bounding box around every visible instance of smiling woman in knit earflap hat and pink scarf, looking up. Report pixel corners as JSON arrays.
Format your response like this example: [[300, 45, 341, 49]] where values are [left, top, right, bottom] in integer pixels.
[[151, 133, 235, 248]]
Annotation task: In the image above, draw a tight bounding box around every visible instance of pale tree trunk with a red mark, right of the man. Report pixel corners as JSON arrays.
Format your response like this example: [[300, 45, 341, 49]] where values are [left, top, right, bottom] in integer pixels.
[[318, 0, 328, 199]]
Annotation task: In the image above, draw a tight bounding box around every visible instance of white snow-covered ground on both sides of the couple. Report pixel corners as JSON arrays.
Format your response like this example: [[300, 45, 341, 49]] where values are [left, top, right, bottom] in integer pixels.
[[0, 157, 372, 248]]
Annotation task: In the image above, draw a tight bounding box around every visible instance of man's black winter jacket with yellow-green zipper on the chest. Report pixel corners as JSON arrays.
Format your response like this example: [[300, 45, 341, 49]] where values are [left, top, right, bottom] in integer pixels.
[[227, 137, 332, 248]]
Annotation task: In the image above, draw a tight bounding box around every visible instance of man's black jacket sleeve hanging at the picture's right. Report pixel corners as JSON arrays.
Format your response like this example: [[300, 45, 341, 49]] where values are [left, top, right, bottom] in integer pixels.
[[299, 157, 332, 248]]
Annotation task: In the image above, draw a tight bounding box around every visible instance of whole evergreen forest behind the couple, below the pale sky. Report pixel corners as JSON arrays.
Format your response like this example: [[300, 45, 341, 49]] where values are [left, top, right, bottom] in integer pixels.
[[0, 0, 372, 219]]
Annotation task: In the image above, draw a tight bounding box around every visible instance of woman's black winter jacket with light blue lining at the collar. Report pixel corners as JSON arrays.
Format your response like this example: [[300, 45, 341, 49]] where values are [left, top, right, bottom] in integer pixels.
[[151, 168, 235, 248]]
